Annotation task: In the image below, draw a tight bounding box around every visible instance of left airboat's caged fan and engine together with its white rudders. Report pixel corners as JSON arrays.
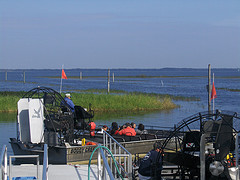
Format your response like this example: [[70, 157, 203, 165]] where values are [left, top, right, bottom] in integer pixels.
[[18, 87, 94, 147]]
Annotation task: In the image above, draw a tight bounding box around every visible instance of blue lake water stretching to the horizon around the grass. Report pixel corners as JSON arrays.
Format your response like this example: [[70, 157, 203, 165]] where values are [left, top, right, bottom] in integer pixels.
[[0, 69, 240, 154]]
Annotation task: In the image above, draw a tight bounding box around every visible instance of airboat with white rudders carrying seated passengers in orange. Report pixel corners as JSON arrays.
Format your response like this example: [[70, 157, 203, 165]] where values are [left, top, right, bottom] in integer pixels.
[[10, 87, 166, 164]]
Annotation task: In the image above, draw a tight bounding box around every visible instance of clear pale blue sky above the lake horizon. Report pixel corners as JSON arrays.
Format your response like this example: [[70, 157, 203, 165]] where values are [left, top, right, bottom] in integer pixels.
[[0, 0, 240, 69]]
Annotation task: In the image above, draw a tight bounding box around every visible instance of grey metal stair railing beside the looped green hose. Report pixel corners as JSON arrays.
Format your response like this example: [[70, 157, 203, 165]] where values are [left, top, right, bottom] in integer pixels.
[[103, 131, 132, 179]]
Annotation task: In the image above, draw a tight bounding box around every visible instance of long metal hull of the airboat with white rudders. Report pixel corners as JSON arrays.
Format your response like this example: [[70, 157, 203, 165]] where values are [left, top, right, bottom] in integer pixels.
[[10, 138, 163, 164]]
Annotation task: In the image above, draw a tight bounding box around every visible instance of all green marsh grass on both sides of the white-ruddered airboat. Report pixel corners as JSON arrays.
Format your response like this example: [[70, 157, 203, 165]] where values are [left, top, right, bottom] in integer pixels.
[[0, 90, 177, 113]]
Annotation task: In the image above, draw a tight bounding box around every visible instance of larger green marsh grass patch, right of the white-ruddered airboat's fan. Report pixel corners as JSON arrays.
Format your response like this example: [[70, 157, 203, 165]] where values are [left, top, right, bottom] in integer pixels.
[[71, 93, 177, 112]]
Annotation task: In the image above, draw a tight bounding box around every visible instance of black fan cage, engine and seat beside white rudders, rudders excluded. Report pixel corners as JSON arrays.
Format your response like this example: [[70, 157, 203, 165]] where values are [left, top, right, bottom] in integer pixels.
[[23, 87, 94, 146]]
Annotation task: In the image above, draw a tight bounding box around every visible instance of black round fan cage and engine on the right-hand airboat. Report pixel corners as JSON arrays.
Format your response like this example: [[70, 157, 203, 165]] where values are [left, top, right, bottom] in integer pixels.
[[162, 110, 240, 179]]
